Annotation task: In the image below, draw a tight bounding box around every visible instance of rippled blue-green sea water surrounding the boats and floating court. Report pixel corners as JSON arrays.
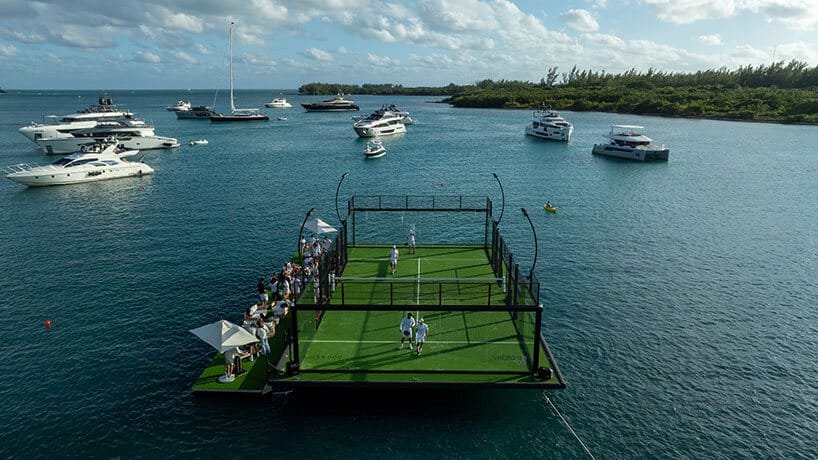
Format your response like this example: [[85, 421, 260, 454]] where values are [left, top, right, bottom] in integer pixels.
[[0, 91, 818, 458]]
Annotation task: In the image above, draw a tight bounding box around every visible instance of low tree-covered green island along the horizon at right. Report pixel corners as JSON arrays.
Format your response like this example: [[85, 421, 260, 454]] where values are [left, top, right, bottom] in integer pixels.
[[298, 61, 818, 124]]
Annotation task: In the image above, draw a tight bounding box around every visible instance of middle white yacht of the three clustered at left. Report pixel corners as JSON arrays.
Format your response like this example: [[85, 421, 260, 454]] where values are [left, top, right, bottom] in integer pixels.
[[36, 120, 179, 155]]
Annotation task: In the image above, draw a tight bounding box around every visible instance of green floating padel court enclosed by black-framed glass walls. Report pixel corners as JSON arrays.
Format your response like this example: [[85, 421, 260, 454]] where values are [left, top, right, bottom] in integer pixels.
[[267, 196, 565, 391]]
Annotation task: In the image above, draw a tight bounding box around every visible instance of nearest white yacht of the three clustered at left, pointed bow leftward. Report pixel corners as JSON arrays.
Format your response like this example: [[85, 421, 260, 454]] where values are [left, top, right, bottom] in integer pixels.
[[5, 143, 153, 187]]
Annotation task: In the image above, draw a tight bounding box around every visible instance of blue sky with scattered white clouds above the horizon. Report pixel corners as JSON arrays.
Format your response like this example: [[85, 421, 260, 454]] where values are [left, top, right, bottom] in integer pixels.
[[0, 0, 818, 89]]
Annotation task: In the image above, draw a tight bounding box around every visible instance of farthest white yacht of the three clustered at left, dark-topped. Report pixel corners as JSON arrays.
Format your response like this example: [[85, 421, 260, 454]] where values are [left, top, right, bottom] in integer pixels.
[[19, 93, 135, 142]]
